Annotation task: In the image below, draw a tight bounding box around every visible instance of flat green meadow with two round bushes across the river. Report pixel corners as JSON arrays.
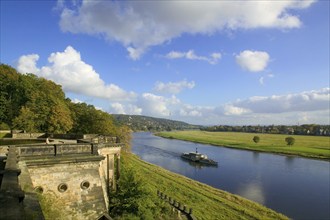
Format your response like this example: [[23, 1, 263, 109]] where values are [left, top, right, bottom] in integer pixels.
[[157, 131, 330, 160]]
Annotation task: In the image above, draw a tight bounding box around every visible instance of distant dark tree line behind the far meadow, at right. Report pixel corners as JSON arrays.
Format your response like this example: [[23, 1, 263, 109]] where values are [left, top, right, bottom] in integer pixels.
[[201, 124, 330, 136]]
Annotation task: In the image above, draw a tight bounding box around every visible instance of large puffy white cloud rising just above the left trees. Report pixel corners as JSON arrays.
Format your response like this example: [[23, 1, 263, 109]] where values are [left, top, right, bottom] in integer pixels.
[[17, 46, 136, 100]]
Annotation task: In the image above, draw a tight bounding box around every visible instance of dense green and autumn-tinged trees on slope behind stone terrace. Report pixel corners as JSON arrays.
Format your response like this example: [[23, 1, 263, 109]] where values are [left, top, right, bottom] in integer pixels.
[[0, 64, 128, 139]]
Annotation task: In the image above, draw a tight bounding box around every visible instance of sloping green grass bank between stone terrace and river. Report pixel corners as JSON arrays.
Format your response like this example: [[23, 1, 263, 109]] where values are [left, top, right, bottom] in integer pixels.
[[123, 154, 287, 220]]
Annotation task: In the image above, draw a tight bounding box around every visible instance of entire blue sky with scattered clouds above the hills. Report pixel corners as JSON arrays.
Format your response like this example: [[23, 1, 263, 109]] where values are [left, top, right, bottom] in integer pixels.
[[0, 0, 330, 125]]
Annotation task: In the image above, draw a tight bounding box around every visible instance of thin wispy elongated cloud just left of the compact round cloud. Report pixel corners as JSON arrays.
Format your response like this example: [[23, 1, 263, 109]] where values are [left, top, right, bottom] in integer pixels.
[[165, 50, 221, 64]]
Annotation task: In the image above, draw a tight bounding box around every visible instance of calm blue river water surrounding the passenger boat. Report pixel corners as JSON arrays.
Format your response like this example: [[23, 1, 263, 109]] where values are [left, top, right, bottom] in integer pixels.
[[132, 132, 330, 220]]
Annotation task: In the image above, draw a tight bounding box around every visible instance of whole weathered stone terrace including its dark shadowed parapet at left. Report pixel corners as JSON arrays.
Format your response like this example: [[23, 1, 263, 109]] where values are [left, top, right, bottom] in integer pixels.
[[0, 137, 122, 219]]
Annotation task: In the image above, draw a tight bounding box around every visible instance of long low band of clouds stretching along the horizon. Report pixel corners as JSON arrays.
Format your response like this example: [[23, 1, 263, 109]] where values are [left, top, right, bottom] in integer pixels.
[[111, 88, 330, 125]]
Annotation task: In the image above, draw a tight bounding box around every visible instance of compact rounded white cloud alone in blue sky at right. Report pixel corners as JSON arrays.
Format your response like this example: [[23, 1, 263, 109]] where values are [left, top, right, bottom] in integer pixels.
[[236, 50, 270, 72]]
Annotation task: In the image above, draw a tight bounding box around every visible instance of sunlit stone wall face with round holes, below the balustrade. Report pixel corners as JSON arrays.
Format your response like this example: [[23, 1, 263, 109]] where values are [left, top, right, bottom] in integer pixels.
[[28, 158, 107, 219]]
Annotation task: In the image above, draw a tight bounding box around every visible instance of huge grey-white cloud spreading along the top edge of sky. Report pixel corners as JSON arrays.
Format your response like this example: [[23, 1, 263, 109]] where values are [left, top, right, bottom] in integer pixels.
[[57, 0, 314, 59]]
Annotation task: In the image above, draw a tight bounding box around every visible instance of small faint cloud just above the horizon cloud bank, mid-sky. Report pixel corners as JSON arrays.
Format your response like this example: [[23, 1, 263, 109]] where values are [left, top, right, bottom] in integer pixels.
[[154, 80, 195, 94]]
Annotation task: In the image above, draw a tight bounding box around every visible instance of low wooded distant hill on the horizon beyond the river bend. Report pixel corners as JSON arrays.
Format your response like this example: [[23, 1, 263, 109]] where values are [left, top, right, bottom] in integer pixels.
[[113, 114, 202, 131]]
